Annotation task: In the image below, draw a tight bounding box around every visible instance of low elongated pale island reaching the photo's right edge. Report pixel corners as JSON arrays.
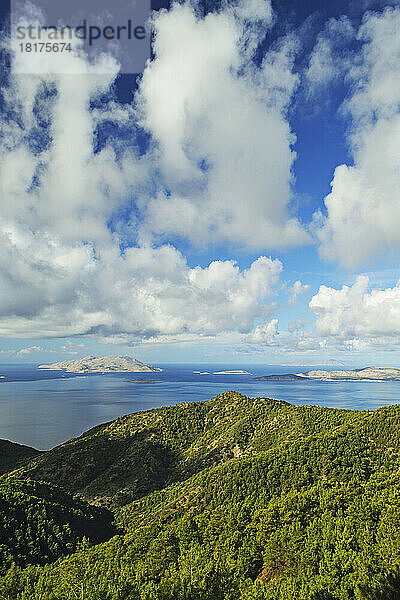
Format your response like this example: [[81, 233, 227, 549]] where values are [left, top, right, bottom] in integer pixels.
[[252, 367, 400, 381]]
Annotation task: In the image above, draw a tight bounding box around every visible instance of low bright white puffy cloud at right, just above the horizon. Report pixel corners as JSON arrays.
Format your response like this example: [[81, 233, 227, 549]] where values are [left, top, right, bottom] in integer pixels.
[[243, 275, 400, 353]]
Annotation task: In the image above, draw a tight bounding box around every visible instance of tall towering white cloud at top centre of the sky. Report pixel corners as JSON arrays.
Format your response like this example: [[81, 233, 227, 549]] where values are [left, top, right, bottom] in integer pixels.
[[137, 2, 308, 249]]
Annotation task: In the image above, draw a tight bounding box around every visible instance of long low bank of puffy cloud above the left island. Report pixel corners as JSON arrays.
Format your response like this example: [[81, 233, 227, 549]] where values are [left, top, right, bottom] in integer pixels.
[[0, 246, 282, 338]]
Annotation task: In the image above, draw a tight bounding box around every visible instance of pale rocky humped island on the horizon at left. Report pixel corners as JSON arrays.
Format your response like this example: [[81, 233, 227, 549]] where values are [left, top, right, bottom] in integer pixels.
[[38, 356, 162, 373]]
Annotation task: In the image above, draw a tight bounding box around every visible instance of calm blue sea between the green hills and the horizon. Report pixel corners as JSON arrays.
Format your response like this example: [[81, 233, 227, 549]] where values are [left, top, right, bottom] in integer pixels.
[[0, 364, 400, 450]]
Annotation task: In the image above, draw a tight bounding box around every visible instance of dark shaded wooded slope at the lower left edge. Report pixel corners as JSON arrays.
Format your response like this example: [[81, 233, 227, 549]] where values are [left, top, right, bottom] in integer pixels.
[[0, 476, 117, 572]]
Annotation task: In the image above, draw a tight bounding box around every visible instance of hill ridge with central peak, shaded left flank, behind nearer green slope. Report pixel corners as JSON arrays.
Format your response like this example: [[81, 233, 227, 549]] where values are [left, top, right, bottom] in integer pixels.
[[14, 392, 378, 506]]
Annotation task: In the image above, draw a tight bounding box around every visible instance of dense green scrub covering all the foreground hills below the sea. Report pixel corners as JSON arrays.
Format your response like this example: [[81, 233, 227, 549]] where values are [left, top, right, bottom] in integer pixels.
[[0, 392, 400, 600]]
